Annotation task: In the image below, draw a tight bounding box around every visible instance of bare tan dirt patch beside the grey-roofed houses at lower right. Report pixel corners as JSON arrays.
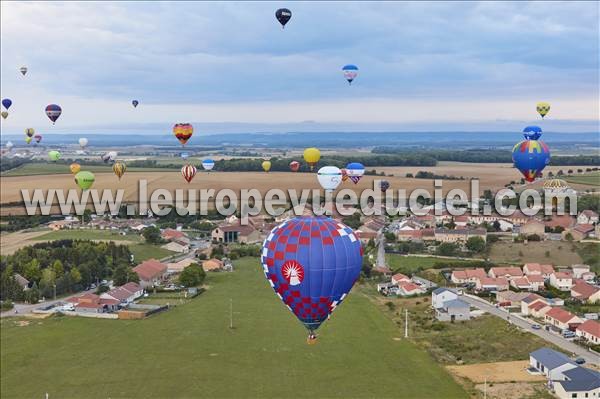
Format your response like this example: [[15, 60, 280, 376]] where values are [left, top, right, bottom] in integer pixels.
[[446, 360, 545, 383]]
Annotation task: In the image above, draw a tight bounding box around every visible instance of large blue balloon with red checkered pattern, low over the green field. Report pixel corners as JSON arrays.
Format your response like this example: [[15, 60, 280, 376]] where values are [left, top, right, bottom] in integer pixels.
[[261, 216, 362, 343]]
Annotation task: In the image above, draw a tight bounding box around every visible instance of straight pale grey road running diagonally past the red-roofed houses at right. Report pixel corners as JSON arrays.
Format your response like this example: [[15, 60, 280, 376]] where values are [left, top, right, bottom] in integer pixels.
[[461, 295, 600, 365]]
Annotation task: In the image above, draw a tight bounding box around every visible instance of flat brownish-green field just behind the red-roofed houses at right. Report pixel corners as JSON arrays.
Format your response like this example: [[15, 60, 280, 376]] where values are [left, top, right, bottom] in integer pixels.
[[489, 241, 582, 266]]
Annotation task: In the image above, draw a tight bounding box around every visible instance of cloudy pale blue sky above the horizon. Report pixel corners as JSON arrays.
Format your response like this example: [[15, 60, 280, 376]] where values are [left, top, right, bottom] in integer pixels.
[[0, 1, 600, 134]]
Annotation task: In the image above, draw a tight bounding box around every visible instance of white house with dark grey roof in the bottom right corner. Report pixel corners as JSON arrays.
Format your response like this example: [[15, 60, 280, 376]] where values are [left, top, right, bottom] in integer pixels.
[[553, 366, 600, 399]]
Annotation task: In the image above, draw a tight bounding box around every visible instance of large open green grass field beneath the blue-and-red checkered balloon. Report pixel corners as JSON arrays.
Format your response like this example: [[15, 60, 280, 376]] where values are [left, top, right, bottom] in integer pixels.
[[0, 258, 467, 398]]
